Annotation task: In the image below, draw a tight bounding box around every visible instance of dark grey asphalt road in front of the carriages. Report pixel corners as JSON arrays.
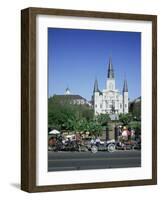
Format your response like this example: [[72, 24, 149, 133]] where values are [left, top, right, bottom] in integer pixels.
[[48, 150, 141, 171]]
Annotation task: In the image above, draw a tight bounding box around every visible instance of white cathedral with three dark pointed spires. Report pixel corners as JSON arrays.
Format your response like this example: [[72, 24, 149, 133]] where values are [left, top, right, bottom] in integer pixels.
[[93, 58, 128, 115]]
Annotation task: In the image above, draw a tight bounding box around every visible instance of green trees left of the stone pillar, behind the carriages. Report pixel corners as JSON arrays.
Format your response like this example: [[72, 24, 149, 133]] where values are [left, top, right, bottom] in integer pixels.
[[48, 96, 110, 136]]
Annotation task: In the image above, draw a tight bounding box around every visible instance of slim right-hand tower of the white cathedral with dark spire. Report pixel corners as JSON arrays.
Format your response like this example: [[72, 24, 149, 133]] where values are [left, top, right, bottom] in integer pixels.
[[123, 79, 129, 114]]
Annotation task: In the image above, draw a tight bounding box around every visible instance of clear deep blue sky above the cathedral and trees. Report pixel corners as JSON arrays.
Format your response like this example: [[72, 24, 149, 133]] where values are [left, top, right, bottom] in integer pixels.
[[48, 28, 141, 100]]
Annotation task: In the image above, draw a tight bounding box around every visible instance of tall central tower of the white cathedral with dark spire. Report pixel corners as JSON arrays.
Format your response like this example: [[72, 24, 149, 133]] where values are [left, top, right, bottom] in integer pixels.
[[106, 57, 115, 90]]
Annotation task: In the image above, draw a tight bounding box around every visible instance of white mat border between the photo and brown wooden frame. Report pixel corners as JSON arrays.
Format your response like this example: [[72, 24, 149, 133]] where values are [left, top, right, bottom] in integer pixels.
[[36, 15, 152, 186]]
